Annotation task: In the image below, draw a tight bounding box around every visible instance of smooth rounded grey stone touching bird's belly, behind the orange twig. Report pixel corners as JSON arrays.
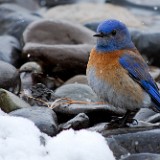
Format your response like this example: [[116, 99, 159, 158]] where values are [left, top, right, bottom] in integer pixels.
[[55, 83, 100, 102]]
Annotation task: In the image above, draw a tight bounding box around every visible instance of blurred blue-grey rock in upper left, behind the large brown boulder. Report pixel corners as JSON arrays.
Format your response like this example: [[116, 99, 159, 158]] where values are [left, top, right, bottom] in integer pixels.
[[0, 3, 40, 41]]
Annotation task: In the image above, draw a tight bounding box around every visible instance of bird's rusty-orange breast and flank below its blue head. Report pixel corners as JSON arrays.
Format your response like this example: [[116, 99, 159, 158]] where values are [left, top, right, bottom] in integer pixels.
[[87, 49, 143, 107]]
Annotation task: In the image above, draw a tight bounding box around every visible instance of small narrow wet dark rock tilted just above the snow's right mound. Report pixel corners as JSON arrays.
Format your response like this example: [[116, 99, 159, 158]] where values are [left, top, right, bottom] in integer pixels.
[[59, 113, 89, 130]]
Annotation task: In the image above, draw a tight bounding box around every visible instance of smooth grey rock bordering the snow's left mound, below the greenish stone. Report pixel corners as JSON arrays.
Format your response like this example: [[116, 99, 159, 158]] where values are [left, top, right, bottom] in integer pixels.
[[9, 106, 58, 136]]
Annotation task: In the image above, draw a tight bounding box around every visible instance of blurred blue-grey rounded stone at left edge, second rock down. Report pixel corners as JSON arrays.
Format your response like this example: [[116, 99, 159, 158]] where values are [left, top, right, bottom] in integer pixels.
[[0, 35, 21, 67]]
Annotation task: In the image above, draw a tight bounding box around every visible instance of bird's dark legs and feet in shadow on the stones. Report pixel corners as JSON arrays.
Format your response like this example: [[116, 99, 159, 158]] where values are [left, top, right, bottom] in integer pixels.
[[109, 110, 137, 128]]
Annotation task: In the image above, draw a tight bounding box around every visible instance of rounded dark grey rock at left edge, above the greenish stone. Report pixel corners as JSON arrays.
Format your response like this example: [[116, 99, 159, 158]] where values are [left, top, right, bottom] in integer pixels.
[[0, 61, 21, 94]]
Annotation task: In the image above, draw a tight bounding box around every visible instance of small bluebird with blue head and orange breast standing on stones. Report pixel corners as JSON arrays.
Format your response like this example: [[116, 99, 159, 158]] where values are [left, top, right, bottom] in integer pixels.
[[86, 19, 160, 126]]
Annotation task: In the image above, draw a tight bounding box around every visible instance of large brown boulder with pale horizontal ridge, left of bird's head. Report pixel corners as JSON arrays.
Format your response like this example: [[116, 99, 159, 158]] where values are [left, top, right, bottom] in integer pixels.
[[23, 20, 95, 80]]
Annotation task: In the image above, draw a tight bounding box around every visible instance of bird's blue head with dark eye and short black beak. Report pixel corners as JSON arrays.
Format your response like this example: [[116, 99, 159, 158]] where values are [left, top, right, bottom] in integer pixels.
[[94, 19, 135, 52]]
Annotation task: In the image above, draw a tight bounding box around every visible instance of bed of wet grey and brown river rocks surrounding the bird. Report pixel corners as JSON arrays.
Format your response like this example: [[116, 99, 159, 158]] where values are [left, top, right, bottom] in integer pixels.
[[0, 0, 160, 160]]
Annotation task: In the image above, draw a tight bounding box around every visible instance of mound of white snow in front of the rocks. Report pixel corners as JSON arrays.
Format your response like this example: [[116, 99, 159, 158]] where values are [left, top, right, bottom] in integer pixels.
[[0, 114, 115, 160]]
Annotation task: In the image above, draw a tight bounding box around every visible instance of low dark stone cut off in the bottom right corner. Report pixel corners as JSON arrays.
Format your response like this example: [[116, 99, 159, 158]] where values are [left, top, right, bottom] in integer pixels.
[[121, 153, 160, 160]]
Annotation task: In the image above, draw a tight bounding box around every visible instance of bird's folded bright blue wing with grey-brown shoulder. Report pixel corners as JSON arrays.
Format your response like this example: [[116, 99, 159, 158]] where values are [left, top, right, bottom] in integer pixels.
[[119, 54, 160, 111]]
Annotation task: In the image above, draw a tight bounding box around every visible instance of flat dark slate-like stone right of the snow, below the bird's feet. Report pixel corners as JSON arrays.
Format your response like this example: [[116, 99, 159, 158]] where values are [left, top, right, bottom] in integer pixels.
[[106, 129, 160, 154]]
